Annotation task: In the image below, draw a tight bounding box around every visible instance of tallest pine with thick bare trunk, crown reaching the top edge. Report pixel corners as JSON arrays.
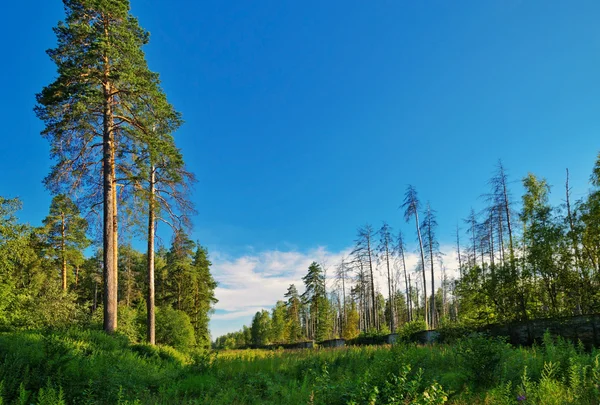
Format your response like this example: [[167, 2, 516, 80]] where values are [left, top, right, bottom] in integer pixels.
[[36, 0, 178, 333]]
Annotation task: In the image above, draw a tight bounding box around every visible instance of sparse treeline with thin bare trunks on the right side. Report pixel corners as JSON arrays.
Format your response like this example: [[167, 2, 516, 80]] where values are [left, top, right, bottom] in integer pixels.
[[216, 154, 600, 348]]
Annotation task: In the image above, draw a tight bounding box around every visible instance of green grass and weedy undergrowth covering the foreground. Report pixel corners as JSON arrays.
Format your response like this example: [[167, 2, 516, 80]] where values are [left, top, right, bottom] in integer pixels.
[[0, 330, 600, 405]]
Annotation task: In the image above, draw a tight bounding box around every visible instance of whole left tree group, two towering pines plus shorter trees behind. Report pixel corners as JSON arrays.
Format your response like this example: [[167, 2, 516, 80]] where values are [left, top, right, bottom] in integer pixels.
[[0, 0, 216, 347]]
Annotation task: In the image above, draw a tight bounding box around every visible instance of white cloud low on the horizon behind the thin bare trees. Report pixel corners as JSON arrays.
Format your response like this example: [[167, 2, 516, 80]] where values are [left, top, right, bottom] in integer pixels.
[[211, 246, 457, 338]]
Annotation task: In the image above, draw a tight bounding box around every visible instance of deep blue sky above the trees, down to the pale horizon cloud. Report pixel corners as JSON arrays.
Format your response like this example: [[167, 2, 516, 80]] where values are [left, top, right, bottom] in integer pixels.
[[0, 0, 600, 334]]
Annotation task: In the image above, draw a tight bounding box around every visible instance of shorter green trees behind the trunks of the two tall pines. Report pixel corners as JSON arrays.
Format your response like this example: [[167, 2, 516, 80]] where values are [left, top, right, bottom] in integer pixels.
[[0, 195, 216, 348]]
